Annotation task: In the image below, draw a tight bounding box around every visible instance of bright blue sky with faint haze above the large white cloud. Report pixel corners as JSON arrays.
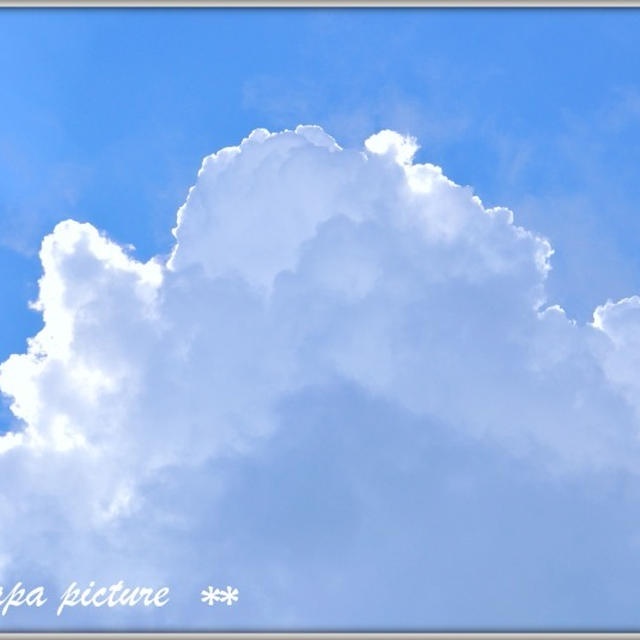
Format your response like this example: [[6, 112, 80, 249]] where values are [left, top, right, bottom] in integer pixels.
[[0, 9, 640, 357]]
